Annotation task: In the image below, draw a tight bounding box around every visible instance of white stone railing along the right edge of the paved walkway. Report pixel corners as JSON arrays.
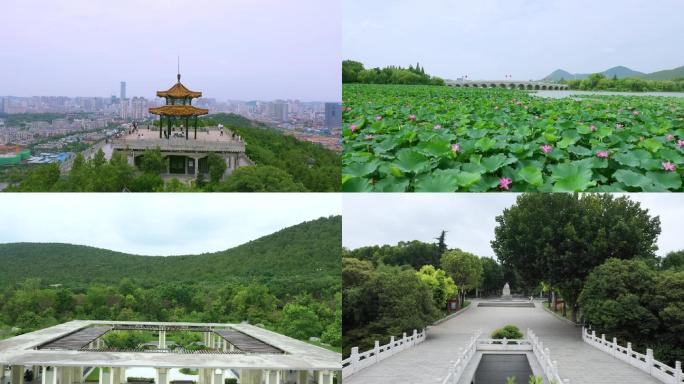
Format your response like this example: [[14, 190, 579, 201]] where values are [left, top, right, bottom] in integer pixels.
[[582, 327, 684, 384]]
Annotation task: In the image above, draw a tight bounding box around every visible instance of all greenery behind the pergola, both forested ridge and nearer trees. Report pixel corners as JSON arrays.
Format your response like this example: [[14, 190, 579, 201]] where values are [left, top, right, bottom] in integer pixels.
[[0, 216, 342, 346]]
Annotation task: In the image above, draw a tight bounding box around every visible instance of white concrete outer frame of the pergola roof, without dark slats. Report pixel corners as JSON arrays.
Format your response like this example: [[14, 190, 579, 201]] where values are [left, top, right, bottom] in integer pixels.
[[0, 320, 342, 371]]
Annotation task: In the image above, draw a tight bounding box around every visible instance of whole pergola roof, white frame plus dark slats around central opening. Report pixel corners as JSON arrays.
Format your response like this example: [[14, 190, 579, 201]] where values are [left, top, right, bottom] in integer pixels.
[[0, 320, 342, 370]]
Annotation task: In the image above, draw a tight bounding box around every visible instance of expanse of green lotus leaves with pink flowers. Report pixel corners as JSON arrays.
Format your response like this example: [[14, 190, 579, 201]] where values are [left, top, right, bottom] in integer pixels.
[[342, 84, 684, 192]]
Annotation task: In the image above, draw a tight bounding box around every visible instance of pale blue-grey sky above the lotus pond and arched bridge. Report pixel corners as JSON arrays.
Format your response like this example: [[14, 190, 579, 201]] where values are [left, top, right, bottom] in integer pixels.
[[342, 0, 684, 80]]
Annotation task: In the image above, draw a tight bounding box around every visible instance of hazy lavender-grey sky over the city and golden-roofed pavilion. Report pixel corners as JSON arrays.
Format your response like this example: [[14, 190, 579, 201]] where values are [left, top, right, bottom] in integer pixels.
[[0, 0, 342, 101]]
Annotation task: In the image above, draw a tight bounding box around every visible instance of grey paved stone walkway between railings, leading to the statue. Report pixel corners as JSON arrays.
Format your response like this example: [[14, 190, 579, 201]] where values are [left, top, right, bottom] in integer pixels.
[[344, 302, 660, 384]]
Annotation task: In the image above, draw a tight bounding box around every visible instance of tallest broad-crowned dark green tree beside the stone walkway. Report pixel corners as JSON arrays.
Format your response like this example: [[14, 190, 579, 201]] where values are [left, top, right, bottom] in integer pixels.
[[492, 193, 660, 320]]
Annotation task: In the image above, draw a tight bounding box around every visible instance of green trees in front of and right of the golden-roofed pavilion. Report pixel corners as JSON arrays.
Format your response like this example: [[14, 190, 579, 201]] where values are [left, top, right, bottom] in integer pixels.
[[5, 113, 341, 192]]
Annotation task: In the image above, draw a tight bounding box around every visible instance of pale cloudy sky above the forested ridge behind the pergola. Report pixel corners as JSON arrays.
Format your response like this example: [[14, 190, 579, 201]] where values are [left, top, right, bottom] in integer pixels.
[[0, 193, 341, 256]]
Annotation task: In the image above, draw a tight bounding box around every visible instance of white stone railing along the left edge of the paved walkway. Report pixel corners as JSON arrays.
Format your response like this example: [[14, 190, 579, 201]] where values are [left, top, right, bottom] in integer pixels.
[[342, 329, 425, 378]]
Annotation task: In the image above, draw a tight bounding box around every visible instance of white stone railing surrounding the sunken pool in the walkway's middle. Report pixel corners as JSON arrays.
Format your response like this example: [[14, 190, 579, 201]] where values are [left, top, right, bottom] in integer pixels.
[[442, 329, 568, 384]]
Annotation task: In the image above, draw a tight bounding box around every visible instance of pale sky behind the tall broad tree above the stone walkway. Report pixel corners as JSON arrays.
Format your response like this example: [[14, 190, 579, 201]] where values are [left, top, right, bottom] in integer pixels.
[[342, 193, 684, 256]]
